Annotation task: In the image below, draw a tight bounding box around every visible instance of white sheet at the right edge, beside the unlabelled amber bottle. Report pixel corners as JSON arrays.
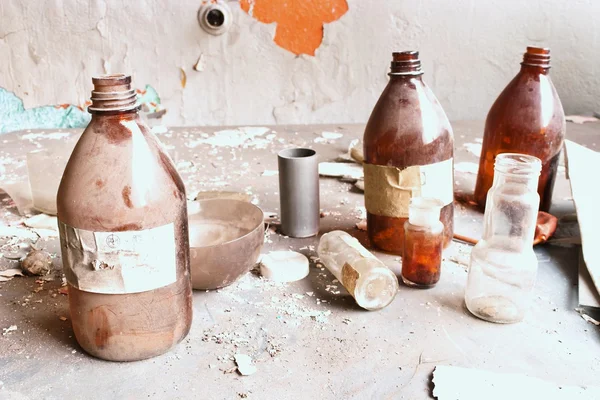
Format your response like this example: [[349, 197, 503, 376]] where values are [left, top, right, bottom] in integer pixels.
[[565, 140, 600, 304]]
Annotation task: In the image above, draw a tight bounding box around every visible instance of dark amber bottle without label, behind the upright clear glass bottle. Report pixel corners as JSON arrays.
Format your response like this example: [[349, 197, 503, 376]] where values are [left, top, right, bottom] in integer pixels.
[[475, 47, 566, 211]]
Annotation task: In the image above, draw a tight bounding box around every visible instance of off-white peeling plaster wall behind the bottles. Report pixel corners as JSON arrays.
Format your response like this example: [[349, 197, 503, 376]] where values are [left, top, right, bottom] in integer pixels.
[[0, 0, 600, 125]]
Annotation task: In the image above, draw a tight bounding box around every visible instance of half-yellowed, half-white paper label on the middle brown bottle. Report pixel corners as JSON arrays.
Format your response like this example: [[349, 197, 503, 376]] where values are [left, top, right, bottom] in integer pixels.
[[364, 158, 454, 218]]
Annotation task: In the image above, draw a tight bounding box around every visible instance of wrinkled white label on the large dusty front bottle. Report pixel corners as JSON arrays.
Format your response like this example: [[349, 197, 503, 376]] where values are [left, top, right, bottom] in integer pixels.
[[58, 221, 177, 294]]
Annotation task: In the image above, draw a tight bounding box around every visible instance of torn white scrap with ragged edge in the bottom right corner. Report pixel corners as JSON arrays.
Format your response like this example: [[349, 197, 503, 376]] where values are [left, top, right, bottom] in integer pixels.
[[433, 365, 600, 400]]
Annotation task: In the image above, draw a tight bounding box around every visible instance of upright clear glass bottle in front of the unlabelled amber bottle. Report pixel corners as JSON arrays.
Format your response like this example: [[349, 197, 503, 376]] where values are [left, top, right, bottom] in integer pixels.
[[465, 153, 542, 323]]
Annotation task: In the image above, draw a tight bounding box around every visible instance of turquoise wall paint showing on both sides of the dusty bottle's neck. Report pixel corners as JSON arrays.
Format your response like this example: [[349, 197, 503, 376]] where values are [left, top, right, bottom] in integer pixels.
[[0, 85, 166, 133]]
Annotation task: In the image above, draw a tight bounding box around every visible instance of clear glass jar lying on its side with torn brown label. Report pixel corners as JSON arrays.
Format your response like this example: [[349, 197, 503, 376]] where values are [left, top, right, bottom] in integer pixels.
[[317, 231, 398, 310]]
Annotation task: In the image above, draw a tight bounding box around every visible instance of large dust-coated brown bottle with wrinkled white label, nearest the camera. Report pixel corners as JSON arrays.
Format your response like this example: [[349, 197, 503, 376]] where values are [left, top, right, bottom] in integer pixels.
[[57, 74, 192, 361]]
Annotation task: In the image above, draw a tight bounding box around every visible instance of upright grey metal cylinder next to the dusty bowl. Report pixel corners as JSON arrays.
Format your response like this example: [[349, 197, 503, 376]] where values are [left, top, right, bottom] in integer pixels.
[[277, 148, 320, 238]]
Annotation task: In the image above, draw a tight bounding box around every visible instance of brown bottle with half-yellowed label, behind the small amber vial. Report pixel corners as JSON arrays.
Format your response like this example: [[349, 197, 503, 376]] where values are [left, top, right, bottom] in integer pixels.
[[364, 51, 454, 254]]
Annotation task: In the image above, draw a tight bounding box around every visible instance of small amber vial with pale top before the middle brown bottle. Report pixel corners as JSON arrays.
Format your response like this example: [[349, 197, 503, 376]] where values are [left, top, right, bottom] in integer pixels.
[[402, 197, 444, 288]]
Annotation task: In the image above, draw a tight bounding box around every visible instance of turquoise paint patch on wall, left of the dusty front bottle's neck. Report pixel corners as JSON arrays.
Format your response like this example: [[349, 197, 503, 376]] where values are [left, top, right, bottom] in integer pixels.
[[0, 88, 90, 133]]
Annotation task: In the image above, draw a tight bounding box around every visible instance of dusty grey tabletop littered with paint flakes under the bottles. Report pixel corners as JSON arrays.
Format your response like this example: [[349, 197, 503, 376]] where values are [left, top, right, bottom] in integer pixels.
[[0, 121, 600, 399]]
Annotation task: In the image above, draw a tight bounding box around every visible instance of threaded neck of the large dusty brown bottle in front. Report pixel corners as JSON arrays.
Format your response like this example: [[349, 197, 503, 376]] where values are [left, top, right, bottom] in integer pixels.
[[88, 74, 140, 115]]
